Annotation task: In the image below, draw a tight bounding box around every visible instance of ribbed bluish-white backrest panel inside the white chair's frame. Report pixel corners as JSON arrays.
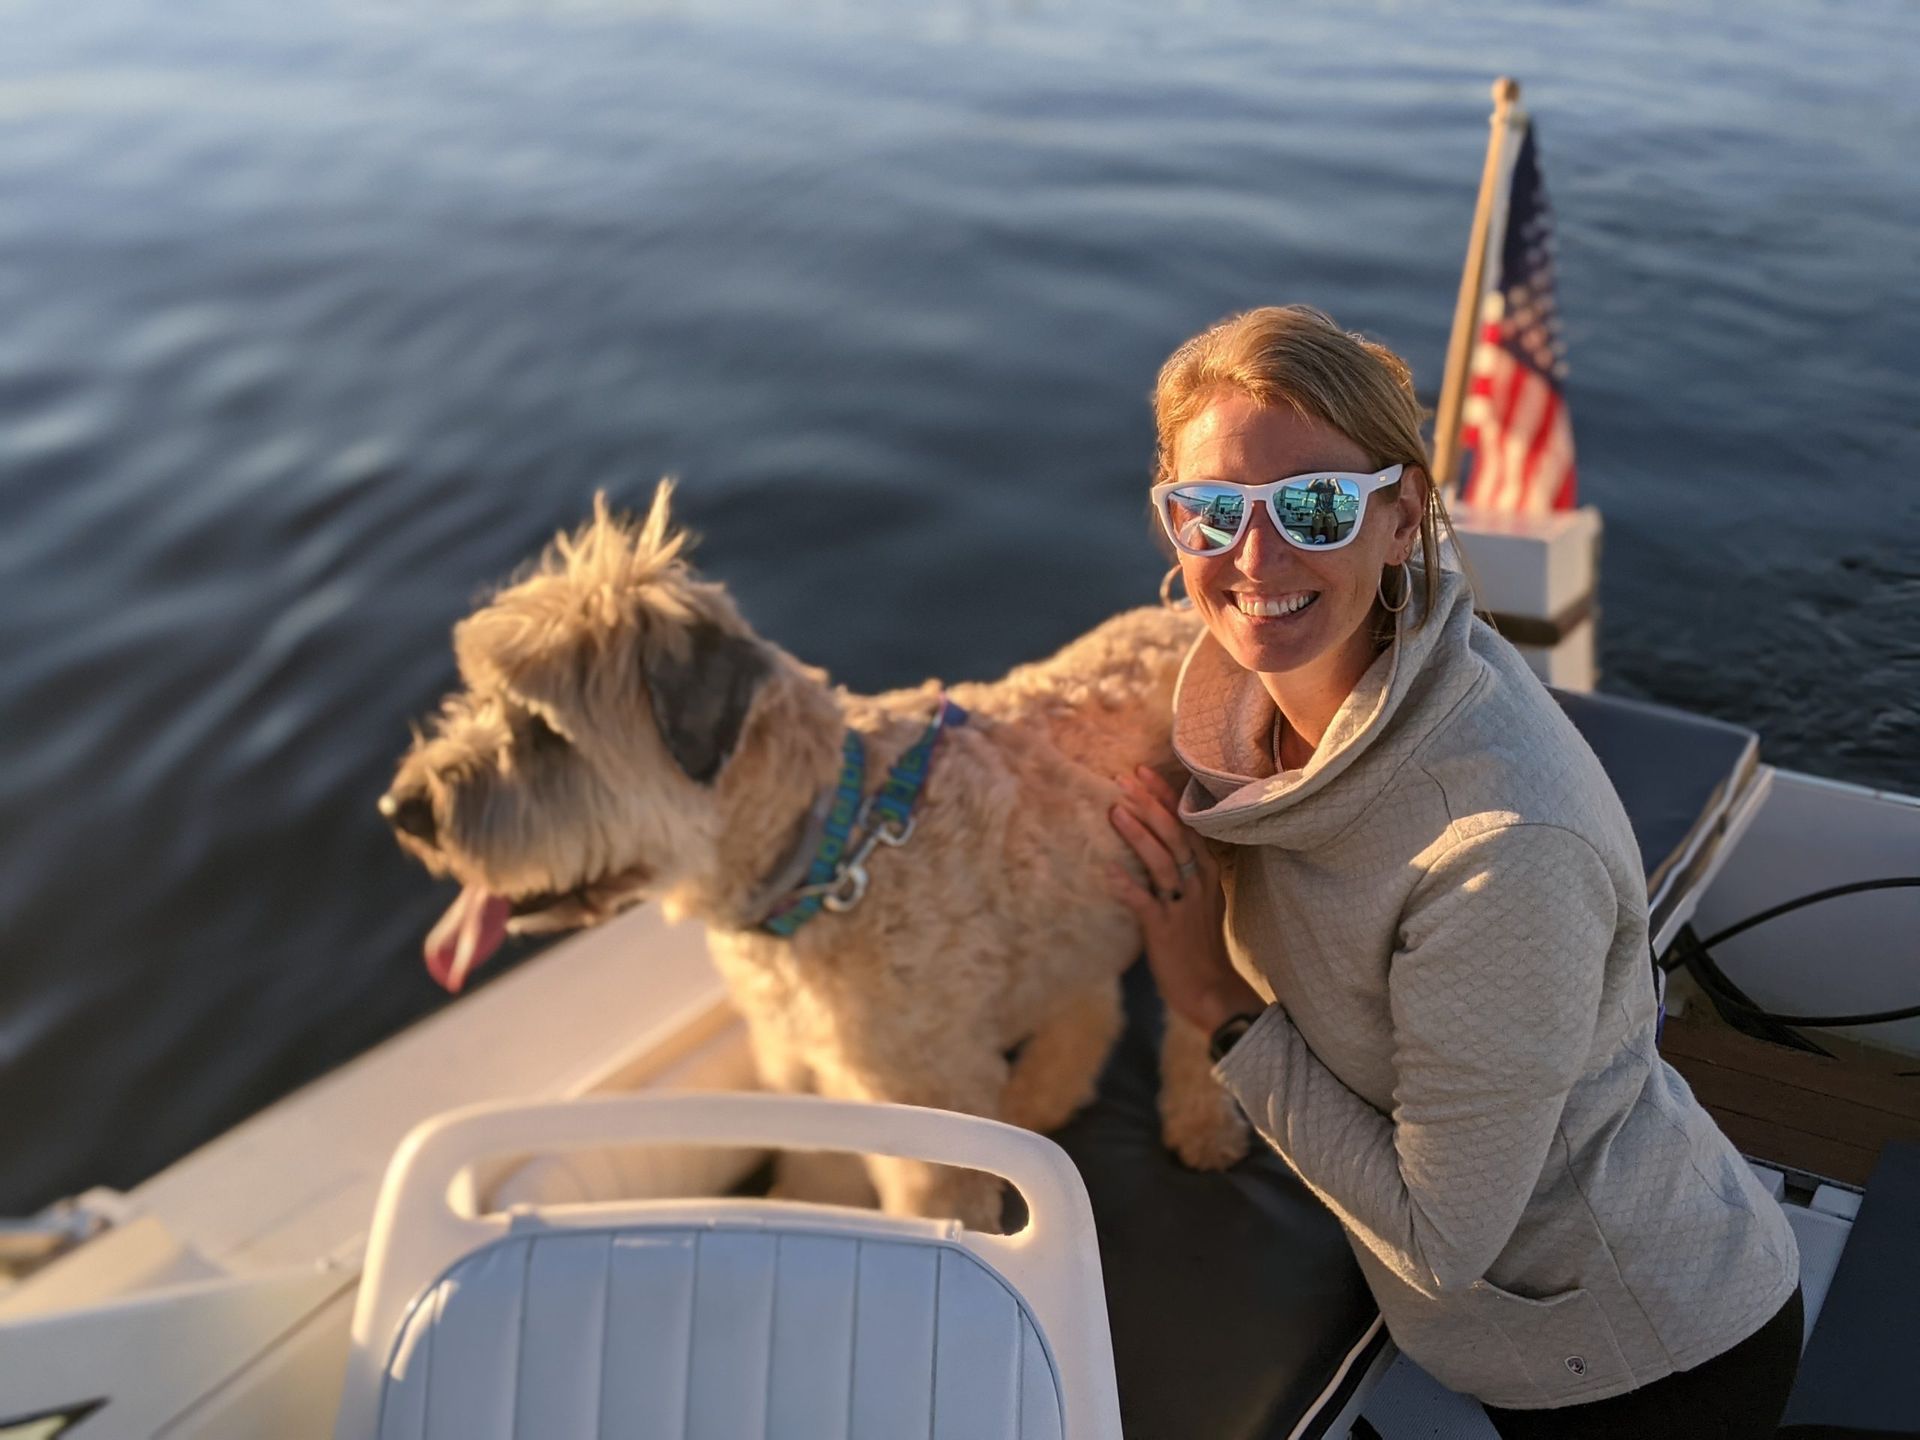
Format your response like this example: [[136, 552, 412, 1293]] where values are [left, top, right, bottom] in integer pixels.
[[378, 1225, 1062, 1440]]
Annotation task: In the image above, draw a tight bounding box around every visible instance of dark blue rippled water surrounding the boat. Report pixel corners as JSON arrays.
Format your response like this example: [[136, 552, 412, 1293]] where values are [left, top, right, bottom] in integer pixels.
[[0, 0, 1920, 1212]]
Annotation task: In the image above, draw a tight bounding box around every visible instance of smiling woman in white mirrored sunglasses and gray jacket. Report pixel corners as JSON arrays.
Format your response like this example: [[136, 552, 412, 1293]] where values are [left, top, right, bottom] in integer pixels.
[[1110, 305, 1801, 1440]]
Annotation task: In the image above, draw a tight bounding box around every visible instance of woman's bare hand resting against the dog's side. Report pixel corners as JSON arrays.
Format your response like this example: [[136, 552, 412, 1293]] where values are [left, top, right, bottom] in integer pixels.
[[1106, 766, 1267, 1033]]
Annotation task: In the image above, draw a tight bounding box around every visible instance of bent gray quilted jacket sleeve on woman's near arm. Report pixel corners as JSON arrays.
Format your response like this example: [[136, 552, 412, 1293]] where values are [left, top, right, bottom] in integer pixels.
[[1215, 824, 1619, 1294]]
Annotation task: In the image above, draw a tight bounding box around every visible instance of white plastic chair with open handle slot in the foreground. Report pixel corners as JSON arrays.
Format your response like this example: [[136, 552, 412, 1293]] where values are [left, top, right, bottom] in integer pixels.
[[336, 1094, 1119, 1440]]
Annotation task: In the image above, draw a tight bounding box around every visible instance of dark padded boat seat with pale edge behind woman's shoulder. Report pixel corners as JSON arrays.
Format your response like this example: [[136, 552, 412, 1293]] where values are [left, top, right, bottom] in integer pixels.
[[1549, 687, 1772, 952]]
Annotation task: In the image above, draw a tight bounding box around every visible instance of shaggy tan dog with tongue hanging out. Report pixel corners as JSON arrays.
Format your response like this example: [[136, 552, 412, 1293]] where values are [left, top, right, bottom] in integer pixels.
[[380, 482, 1246, 1229]]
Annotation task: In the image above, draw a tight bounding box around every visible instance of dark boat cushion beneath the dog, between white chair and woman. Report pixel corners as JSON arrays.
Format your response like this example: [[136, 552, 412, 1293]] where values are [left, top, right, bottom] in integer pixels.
[[1052, 962, 1384, 1440]]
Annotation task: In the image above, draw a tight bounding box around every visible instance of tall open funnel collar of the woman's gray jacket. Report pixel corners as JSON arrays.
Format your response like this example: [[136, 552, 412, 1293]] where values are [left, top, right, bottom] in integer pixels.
[[1173, 564, 1486, 851]]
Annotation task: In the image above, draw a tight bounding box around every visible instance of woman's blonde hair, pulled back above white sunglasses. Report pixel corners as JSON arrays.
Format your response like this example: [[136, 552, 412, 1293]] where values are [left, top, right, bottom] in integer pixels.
[[1154, 305, 1473, 628]]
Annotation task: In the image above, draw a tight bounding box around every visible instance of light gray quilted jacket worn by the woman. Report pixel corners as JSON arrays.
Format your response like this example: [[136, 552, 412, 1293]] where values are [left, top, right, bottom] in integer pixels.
[[1175, 570, 1799, 1409]]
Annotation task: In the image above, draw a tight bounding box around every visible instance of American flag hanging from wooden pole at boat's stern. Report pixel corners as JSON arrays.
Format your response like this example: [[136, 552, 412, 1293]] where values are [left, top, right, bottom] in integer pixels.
[[1459, 121, 1574, 515]]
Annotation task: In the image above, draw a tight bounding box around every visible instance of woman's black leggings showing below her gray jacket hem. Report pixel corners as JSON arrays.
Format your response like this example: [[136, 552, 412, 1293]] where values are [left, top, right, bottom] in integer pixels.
[[1486, 1286, 1803, 1440]]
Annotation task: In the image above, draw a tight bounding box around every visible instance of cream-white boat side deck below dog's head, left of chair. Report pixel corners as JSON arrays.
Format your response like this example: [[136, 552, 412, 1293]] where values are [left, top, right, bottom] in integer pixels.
[[0, 910, 733, 1440]]
